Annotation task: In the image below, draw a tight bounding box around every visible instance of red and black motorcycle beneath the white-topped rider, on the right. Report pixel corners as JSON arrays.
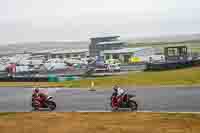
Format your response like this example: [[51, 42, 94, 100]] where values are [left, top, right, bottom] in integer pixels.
[[110, 92, 138, 111]]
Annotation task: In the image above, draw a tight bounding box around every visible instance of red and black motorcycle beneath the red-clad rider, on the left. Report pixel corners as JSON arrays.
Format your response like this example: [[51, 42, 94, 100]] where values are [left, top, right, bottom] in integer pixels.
[[32, 96, 56, 111]]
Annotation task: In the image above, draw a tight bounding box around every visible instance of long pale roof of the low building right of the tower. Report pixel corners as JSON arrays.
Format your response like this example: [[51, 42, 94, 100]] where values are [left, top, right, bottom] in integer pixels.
[[103, 47, 152, 54]]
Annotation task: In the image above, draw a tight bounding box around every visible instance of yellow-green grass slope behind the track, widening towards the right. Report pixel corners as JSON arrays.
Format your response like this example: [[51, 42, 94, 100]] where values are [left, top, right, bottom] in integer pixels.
[[65, 67, 200, 88]]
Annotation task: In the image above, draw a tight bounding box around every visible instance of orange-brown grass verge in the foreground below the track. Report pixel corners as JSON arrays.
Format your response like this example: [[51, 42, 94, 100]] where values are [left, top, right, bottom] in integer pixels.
[[0, 112, 200, 133]]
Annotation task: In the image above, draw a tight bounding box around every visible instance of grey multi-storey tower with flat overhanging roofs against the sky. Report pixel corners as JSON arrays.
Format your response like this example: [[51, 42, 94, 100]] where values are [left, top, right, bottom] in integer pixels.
[[89, 36, 125, 57]]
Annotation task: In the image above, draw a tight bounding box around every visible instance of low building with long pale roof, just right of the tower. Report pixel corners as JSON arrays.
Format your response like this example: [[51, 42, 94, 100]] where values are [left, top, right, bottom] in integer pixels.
[[101, 47, 162, 63]]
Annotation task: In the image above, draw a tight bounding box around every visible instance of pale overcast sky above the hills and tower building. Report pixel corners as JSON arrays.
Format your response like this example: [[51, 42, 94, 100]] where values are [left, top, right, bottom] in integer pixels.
[[0, 0, 200, 44]]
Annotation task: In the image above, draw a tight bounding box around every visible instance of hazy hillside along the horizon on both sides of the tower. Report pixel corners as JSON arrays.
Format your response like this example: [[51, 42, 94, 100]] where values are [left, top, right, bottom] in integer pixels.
[[0, 34, 200, 55]]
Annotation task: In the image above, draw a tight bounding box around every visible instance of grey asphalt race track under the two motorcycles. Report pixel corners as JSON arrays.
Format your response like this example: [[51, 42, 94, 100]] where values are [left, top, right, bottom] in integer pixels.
[[0, 87, 200, 112]]
